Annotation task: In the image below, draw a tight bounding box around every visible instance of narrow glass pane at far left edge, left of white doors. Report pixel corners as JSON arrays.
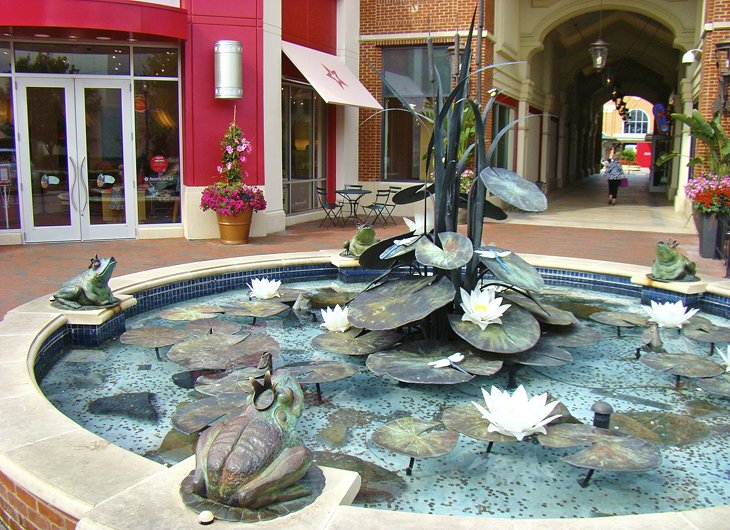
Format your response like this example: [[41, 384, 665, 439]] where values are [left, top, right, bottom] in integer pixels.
[[0, 77, 20, 230]]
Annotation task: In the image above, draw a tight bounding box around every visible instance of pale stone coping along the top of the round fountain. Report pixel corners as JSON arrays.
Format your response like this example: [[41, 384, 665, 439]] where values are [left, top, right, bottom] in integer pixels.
[[0, 251, 730, 530]]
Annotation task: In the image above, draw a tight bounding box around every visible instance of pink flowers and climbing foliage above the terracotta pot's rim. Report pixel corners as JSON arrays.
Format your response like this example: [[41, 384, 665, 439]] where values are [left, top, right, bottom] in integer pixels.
[[200, 122, 266, 217]]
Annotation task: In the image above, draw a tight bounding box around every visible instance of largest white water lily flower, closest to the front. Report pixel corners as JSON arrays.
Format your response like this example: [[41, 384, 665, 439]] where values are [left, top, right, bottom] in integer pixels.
[[471, 385, 561, 441]]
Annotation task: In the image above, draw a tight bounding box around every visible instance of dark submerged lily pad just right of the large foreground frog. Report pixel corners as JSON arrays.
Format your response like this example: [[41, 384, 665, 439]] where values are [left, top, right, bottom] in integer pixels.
[[314, 451, 406, 503]]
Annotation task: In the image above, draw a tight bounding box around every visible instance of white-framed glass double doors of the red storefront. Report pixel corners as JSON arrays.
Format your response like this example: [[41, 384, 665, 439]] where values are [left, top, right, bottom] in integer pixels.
[[17, 77, 137, 242]]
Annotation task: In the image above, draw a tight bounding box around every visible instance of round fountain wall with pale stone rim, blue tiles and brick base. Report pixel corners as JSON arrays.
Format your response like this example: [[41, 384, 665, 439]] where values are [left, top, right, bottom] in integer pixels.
[[0, 251, 730, 529]]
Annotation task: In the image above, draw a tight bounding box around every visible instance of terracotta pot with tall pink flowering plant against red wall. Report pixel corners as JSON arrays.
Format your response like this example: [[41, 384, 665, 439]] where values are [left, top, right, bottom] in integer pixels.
[[200, 119, 266, 245]]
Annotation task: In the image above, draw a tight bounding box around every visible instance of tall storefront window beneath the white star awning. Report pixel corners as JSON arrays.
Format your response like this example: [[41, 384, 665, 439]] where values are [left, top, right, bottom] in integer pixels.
[[282, 83, 327, 213]]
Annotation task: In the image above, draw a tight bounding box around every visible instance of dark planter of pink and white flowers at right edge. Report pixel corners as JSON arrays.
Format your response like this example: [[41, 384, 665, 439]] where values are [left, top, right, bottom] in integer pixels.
[[684, 173, 730, 258]]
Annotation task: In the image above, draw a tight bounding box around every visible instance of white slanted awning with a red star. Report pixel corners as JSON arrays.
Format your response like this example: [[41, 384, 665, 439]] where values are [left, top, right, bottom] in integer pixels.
[[281, 41, 383, 109]]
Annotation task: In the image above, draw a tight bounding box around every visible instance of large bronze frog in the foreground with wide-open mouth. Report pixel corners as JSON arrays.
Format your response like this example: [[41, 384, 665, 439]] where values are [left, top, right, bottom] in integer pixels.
[[192, 371, 312, 509]]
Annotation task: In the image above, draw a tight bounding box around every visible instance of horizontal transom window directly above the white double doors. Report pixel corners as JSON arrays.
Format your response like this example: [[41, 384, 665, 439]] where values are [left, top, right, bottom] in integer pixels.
[[15, 42, 129, 75]]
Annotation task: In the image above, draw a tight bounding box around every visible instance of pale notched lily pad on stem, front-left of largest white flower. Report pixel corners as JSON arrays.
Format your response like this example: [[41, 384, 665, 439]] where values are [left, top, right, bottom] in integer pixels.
[[372, 417, 459, 458]]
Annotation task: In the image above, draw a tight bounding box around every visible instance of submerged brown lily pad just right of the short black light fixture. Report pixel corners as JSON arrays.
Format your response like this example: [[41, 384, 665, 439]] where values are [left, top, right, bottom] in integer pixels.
[[611, 412, 710, 446]]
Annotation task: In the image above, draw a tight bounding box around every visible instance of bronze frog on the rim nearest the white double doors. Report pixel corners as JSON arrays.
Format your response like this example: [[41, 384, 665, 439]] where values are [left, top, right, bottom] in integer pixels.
[[51, 256, 118, 309]]
